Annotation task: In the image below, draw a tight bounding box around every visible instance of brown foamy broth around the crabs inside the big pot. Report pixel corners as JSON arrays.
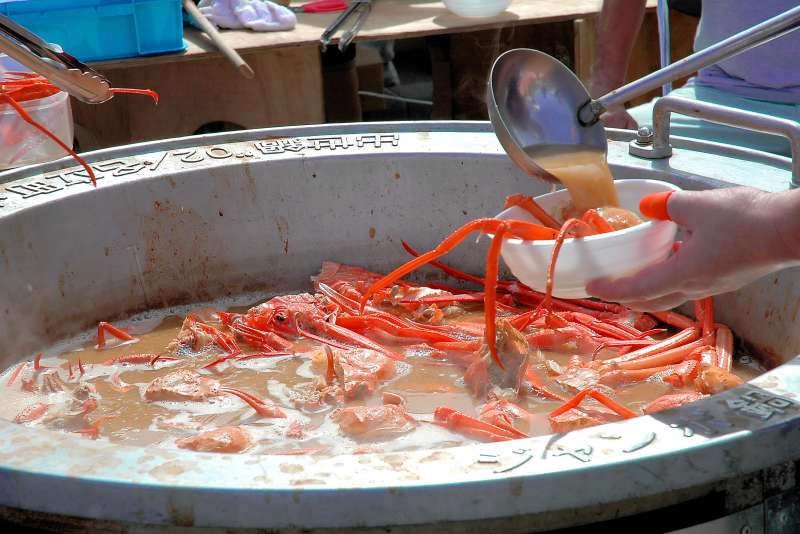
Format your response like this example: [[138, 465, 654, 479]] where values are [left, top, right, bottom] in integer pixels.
[[0, 266, 761, 454]]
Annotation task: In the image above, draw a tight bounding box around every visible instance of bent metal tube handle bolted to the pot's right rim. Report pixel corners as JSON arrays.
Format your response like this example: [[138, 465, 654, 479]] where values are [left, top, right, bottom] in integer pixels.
[[628, 96, 800, 189]]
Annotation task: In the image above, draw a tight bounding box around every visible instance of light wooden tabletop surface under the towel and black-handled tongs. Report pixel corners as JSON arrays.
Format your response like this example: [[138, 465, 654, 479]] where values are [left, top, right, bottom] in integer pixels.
[[93, 0, 656, 69]]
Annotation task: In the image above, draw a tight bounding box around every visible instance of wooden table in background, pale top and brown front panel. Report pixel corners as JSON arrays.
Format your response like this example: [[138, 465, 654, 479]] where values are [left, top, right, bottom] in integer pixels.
[[73, 0, 656, 150]]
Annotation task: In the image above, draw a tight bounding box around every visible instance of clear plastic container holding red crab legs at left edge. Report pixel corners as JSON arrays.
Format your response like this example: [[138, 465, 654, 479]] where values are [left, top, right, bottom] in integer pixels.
[[0, 56, 75, 169]]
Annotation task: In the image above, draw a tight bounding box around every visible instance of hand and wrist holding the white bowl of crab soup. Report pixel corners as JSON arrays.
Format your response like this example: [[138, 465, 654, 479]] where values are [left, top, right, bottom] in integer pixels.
[[587, 187, 800, 311]]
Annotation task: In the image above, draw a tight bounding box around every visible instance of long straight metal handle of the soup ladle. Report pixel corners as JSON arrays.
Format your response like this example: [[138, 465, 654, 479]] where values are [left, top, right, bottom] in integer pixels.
[[578, 6, 800, 125]]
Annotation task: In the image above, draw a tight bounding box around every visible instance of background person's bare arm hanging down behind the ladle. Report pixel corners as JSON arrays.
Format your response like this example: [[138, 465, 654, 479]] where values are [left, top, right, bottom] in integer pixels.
[[589, 0, 647, 128]]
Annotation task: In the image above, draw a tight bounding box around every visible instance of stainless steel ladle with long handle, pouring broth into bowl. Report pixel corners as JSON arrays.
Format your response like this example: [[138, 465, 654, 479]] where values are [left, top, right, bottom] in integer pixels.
[[486, 6, 800, 183]]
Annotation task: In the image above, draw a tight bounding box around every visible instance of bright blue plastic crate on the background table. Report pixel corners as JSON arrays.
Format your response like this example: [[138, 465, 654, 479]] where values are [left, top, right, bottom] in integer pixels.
[[0, 0, 186, 61]]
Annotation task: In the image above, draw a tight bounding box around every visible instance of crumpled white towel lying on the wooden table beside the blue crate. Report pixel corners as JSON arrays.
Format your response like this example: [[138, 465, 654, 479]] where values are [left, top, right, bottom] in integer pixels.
[[197, 0, 297, 32]]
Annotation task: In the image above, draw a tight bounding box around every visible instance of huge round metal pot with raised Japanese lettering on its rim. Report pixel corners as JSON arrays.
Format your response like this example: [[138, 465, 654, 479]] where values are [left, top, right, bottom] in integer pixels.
[[0, 123, 800, 532]]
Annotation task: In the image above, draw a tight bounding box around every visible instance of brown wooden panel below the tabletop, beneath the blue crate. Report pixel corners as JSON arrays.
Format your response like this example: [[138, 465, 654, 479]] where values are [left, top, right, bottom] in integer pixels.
[[72, 47, 325, 150]]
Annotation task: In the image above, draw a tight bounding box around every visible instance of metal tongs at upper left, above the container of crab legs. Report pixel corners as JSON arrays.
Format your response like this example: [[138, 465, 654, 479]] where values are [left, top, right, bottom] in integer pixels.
[[0, 15, 114, 104]]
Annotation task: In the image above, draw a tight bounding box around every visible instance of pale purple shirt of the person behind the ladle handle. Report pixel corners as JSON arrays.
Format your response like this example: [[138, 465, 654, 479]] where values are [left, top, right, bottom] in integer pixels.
[[691, 0, 800, 104]]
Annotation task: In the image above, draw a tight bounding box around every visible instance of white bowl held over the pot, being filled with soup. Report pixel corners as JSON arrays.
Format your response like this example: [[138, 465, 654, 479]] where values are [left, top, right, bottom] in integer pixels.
[[497, 180, 680, 299]]
